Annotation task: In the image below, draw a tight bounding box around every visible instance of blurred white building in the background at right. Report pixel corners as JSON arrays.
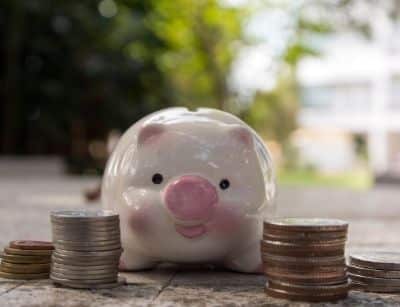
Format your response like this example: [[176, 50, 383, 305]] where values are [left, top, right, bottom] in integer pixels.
[[294, 14, 400, 178]]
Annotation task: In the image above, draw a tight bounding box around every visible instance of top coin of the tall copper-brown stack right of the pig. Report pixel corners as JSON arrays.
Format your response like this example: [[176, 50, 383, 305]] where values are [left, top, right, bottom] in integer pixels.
[[264, 218, 348, 232]]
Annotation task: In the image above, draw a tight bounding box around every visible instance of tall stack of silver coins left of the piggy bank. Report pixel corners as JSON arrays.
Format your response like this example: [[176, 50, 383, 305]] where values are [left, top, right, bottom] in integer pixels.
[[50, 210, 122, 289]]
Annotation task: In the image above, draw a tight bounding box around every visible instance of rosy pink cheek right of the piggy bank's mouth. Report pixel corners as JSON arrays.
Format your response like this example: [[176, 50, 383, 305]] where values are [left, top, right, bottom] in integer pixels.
[[208, 204, 243, 235]]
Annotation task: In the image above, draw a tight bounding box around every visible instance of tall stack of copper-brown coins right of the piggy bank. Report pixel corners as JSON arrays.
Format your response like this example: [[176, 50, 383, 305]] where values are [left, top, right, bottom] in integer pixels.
[[261, 218, 349, 302]]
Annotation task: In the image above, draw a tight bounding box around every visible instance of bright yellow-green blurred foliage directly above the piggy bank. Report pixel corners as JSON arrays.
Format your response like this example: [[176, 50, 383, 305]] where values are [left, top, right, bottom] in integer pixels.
[[148, 0, 242, 109]]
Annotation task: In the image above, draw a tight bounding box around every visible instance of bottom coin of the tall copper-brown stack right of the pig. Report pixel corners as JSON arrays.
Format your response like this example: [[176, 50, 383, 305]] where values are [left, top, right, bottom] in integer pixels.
[[265, 287, 348, 302]]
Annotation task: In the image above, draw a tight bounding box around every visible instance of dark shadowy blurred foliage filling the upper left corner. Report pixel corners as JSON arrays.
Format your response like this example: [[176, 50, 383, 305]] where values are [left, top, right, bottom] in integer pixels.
[[0, 0, 171, 170]]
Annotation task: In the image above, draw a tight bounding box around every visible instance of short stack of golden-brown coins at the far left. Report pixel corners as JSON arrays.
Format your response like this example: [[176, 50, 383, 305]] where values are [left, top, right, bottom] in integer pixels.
[[0, 240, 53, 280]]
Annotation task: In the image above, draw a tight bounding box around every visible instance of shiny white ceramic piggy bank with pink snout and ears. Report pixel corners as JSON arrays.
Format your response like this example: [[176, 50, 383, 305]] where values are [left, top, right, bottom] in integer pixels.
[[102, 108, 275, 272]]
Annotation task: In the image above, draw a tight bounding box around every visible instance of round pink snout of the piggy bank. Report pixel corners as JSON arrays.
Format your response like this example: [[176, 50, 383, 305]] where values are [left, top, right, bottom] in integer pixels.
[[164, 176, 218, 221]]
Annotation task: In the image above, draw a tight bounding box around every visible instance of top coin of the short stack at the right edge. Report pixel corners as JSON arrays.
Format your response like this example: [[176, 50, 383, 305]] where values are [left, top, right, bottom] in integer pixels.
[[350, 252, 400, 271]]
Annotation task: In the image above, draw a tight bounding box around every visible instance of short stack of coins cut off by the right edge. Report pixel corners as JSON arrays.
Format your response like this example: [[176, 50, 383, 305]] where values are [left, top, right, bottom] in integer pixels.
[[348, 252, 400, 293]]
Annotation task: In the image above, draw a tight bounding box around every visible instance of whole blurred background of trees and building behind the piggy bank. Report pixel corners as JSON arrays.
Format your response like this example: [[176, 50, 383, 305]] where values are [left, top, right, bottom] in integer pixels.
[[0, 0, 400, 189]]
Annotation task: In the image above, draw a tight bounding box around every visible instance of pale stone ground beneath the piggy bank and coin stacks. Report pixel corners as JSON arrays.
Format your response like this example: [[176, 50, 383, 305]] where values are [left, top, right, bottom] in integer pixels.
[[0, 166, 400, 307]]
